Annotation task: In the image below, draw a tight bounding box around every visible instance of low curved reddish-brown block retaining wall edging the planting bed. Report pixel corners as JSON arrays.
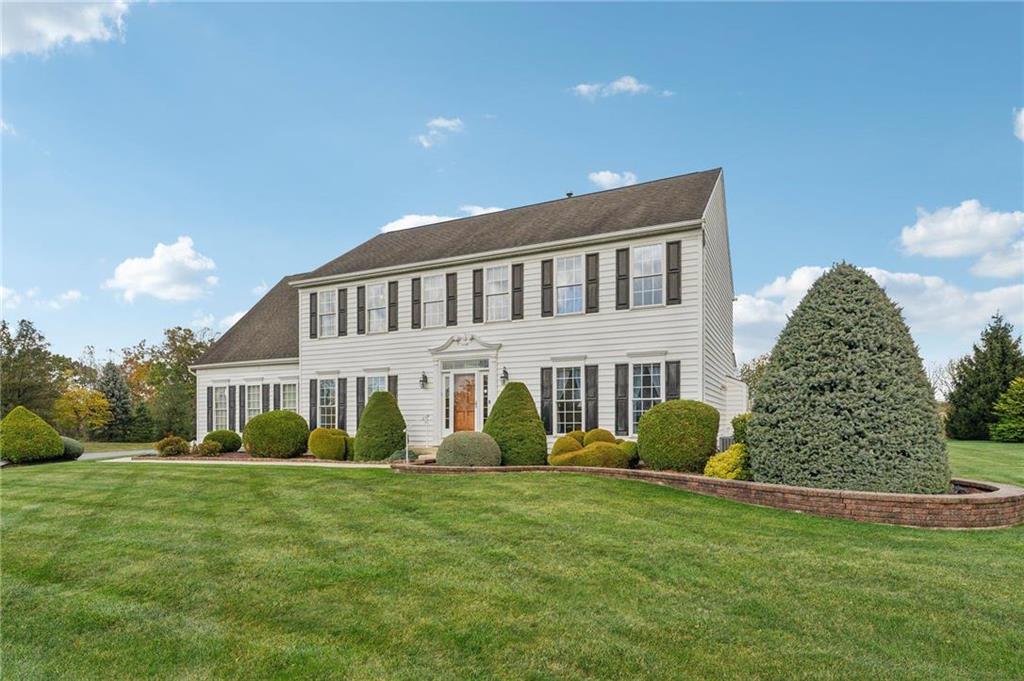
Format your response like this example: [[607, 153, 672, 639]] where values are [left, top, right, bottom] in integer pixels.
[[391, 463, 1024, 529]]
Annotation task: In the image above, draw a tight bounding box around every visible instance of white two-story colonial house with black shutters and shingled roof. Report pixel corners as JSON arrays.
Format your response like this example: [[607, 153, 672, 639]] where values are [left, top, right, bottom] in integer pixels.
[[193, 169, 746, 444]]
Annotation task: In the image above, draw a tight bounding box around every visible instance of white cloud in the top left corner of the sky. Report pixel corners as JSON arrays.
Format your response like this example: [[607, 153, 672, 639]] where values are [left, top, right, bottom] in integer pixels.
[[0, 0, 128, 57]]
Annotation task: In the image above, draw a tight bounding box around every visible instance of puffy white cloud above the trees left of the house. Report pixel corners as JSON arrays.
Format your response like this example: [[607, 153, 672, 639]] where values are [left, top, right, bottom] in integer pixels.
[[103, 237, 217, 302]]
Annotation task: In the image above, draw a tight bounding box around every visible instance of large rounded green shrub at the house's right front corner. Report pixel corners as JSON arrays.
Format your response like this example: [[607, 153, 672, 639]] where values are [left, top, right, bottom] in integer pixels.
[[637, 399, 719, 473]]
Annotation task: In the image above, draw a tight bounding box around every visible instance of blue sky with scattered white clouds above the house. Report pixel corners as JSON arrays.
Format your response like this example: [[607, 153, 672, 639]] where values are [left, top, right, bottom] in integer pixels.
[[0, 3, 1024, 361]]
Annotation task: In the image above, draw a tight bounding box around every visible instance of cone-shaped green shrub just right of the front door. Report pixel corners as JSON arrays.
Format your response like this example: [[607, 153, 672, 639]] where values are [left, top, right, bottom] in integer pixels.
[[483, 381, 548, 466]]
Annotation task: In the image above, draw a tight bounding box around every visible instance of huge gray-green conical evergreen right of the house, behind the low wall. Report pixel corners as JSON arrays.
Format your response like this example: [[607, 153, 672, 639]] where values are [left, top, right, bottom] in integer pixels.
[[745, 263, 949, 494]]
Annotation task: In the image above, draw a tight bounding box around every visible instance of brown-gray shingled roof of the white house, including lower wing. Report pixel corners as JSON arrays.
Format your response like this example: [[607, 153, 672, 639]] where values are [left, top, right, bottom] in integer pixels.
[[196, 168, 722, 365]]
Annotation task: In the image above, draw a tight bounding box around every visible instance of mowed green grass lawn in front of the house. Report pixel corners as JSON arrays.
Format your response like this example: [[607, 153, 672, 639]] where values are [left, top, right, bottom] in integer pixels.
[[0, 445, 1024, 680]]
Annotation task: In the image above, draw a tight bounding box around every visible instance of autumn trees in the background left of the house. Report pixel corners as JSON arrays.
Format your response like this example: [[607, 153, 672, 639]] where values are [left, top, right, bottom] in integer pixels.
[[0, 320, 215, 442]]
